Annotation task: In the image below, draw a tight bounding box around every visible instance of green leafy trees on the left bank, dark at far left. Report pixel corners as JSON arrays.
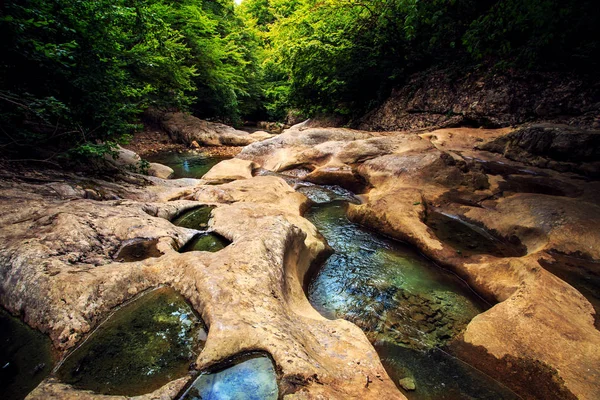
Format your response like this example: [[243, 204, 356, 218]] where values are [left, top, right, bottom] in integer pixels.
[[0, 0, 259, 156]]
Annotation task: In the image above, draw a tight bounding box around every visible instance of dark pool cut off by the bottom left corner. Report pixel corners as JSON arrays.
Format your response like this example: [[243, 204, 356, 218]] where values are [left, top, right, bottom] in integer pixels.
[[0, 308, 54, 400]]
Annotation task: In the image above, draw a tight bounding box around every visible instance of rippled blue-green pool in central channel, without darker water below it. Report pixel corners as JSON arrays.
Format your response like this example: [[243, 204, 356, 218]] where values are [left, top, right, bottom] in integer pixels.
[[307, 202, 485, 349]]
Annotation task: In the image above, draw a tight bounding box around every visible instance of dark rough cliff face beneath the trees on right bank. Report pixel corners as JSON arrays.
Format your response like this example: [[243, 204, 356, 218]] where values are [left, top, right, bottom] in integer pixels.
[[358, 69, 600, 131]]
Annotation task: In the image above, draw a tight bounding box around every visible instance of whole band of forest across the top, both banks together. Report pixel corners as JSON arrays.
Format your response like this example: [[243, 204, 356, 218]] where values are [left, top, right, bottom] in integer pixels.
[[0, 0, 600, 158]]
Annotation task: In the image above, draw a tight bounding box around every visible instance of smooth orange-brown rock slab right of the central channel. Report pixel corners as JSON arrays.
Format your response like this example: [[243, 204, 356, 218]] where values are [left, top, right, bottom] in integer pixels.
[[238, 128, 600, 399]]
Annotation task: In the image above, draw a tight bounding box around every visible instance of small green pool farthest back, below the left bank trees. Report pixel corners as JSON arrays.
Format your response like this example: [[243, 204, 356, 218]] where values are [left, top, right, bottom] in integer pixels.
[[146, 151, 229, 179]]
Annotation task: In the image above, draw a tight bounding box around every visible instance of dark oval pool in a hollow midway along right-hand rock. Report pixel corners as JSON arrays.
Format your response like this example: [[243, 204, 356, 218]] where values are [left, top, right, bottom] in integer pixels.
[[425, 210, 527, 257]]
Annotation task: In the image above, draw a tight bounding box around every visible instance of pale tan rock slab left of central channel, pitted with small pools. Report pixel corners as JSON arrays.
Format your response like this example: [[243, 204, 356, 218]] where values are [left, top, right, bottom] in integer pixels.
[[0, 170, 405, 400]]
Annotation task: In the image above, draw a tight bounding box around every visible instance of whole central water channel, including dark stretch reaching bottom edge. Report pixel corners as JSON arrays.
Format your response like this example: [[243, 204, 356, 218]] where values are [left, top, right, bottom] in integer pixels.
[[306, 201, 516, 400]]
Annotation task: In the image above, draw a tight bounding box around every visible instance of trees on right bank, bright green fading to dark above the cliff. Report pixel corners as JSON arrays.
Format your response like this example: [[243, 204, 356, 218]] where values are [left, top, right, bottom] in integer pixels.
[[240, 0, 600, 116]]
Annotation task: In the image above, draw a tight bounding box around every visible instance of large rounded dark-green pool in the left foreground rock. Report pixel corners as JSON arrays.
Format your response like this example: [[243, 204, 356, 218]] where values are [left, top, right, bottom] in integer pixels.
[[57, 287, 206, 396]]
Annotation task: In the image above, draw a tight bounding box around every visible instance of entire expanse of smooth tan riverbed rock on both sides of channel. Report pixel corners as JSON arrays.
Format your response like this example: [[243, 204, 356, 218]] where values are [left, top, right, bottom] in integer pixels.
[[0, 122, 600, 399]]
